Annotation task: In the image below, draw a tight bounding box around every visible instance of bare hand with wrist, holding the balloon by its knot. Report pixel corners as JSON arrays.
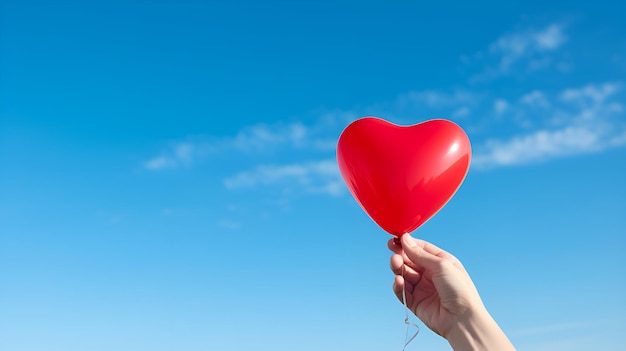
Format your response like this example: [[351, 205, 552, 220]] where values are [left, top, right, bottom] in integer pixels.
[[388, 234, 515, 350]]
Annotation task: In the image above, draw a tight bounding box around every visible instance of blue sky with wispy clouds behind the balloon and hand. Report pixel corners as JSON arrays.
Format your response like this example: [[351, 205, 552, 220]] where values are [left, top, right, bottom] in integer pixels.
[[0, 0, 626, 351]]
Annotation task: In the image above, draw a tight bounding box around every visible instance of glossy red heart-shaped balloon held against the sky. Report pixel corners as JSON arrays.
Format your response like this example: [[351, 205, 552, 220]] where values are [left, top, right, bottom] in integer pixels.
[[337, 117, 472, 236]]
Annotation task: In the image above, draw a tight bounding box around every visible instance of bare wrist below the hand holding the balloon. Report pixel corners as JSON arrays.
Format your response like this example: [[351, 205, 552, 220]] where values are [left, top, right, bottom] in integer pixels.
[[446, 308, 515, 351]]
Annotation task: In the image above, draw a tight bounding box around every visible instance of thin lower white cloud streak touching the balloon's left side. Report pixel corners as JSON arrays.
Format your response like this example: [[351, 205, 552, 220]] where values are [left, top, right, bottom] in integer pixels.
[[224, 160, 344, 195]]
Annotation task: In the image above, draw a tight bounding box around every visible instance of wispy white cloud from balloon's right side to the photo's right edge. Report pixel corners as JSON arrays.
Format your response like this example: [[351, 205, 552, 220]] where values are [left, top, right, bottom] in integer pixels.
[[473, 83, 626, 169]]
